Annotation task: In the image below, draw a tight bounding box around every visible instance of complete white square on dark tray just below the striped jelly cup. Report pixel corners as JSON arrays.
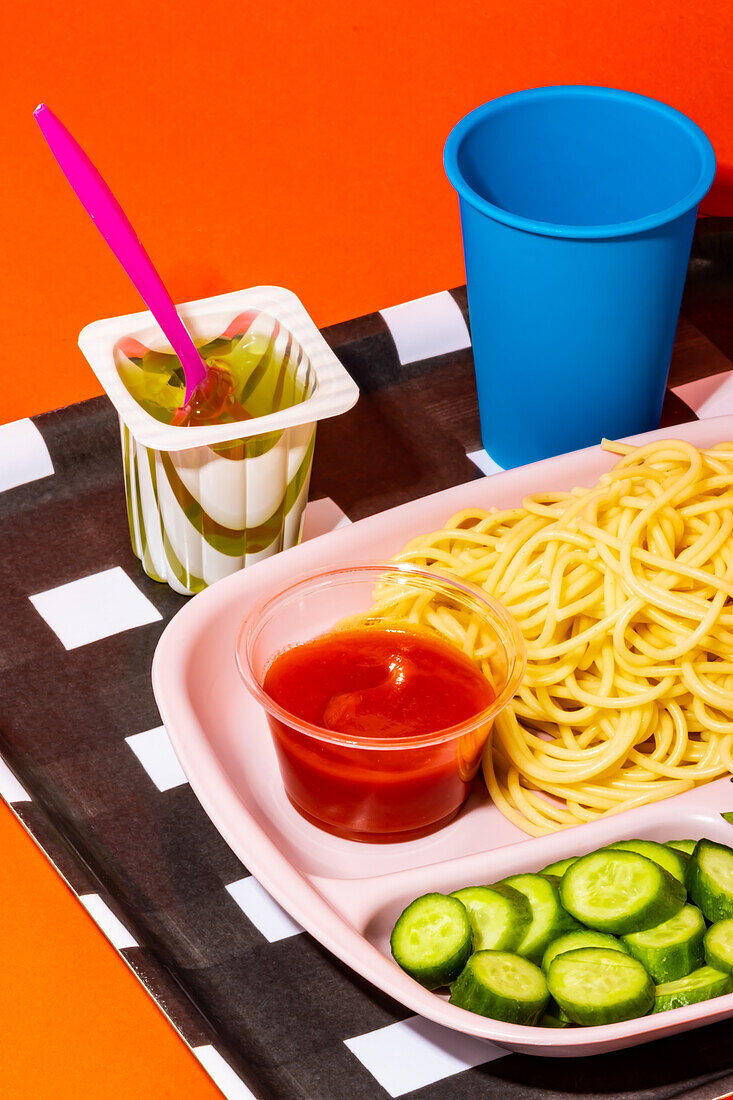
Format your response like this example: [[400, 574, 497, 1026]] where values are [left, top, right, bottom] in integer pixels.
[[30, 565, 163, 649]]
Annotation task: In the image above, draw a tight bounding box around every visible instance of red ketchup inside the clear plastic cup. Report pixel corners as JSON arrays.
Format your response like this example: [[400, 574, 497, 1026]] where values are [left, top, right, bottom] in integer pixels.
[[263, 627, 494, 839]]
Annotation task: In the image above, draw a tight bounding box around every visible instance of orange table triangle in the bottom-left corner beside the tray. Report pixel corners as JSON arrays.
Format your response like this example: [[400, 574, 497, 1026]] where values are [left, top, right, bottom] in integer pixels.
[[0, 803, 221, 1100]]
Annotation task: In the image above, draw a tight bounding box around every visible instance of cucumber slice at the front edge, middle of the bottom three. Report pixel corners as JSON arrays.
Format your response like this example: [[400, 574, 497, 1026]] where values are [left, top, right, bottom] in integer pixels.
[[547, 947, 654, 1026]]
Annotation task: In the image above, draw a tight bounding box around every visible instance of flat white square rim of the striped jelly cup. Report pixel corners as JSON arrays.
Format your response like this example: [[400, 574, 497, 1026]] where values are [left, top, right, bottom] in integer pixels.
[[79, 286, 359, 451]]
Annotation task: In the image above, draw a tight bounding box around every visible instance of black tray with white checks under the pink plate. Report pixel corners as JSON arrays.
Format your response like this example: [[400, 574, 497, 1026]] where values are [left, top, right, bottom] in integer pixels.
[[0, 268, 733, 1100]]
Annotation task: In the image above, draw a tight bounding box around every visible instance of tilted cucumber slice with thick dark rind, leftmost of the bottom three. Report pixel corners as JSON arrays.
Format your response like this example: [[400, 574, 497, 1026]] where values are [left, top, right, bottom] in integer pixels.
[[450, 952, 549, 1024]]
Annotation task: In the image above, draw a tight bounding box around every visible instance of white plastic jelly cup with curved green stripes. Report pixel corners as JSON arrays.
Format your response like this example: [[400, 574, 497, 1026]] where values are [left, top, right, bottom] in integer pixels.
[[79, 287, 359, 595]]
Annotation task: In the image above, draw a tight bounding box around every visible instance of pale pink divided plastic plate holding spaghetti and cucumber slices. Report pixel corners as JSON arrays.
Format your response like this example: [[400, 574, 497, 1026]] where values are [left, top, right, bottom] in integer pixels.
[[153, 417, 733, 1057]]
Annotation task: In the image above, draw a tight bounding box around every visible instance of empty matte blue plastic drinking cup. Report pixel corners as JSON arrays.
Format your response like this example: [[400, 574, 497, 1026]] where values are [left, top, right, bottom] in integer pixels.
[[445, 87, 715, 469]]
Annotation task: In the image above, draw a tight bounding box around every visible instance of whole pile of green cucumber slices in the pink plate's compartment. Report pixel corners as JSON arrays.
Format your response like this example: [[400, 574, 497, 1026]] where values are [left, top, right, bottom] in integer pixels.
[[390, 839, 733, 1027]]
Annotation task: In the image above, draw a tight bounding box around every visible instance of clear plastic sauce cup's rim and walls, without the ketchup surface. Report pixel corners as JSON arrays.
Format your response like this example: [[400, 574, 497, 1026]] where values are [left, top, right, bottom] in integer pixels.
[[237, 563, 525, 842]]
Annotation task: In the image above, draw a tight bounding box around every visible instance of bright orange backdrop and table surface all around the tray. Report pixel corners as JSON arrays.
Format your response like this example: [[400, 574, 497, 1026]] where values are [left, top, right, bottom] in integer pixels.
[[0, 0, 733, 1100]]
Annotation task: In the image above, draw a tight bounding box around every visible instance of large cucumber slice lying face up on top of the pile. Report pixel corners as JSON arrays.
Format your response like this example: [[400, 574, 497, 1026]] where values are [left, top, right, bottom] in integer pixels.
[[560, 848, 686, 935]]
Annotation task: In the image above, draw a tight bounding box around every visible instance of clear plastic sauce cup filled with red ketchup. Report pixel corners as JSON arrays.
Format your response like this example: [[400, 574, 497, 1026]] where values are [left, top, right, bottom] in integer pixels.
[[237, 563, 525, 842]]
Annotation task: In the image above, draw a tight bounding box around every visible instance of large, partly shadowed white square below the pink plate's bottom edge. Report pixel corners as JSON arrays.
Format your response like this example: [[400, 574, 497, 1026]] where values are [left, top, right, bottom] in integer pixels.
[[344, 1016, 508, 1097]]
